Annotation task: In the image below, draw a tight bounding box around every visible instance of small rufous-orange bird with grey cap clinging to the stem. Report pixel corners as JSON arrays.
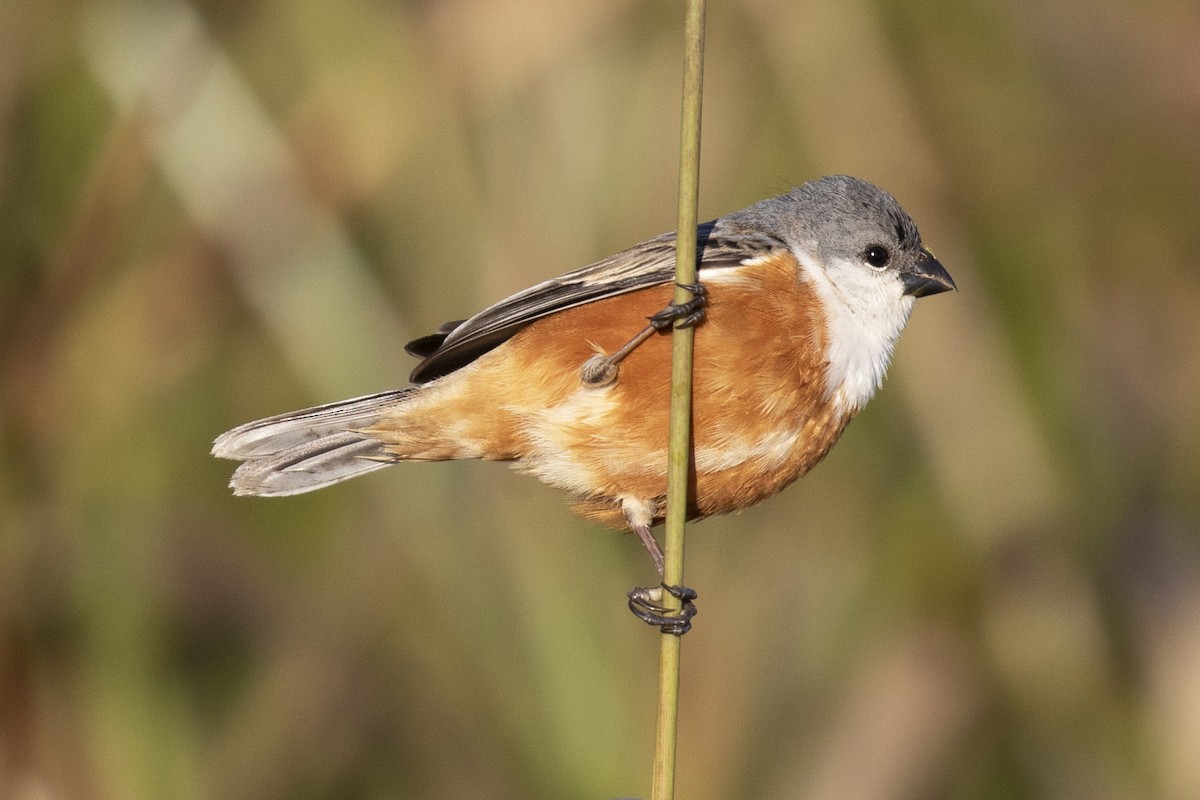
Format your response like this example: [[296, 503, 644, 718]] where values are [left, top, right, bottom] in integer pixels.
[[212, 175, 955, 633]]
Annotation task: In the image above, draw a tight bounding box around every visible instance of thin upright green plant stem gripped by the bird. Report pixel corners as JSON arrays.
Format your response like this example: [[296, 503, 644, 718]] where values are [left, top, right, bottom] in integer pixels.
[[650, 0, 704, 800]]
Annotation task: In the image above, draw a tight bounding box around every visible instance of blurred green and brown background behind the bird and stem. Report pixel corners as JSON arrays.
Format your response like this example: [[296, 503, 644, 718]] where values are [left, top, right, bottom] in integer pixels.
[[0, 0, 1200, 800]]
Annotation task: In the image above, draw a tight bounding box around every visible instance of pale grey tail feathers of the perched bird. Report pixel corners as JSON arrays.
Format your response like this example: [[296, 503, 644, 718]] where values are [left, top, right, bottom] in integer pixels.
[[212, 389, 415, 497]]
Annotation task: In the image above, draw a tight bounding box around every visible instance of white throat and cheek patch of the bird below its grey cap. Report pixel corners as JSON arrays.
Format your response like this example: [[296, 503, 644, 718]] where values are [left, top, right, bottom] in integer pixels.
[[794, 249, 914, 414]]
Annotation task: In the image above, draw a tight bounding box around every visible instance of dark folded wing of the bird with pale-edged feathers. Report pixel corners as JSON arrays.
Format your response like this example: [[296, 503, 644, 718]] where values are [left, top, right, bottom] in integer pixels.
[[404, 221, 782, 384]]
